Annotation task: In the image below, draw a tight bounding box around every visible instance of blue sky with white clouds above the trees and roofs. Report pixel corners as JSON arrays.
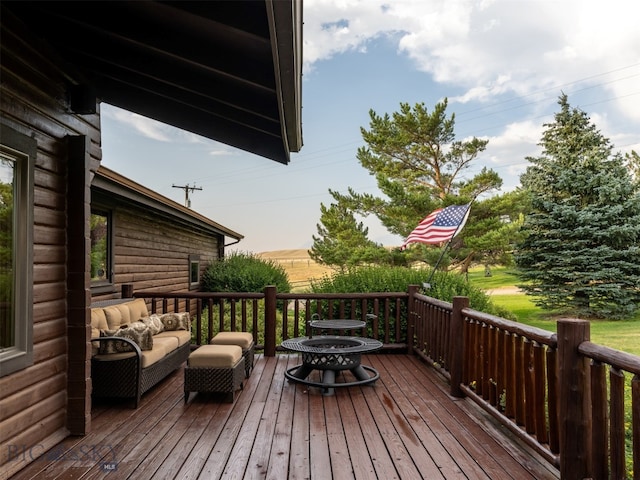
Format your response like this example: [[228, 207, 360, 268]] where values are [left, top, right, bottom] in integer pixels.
[[101, 0, 640, 252]]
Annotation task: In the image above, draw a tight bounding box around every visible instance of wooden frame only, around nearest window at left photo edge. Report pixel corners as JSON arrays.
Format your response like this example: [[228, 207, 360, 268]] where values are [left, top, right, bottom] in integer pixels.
[[0, 123, 38, 377]]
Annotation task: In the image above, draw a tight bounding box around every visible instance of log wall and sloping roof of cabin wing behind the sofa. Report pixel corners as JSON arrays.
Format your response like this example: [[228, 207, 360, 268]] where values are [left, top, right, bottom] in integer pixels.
[[91, 166, 243, 306]]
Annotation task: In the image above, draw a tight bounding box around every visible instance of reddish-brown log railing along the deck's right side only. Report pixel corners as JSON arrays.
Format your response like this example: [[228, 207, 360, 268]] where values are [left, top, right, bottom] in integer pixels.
[[409, 293, 640, 480]]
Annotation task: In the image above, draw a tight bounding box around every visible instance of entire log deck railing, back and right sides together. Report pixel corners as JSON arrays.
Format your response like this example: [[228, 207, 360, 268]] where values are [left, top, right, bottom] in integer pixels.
[[127, 286, 640, 480]]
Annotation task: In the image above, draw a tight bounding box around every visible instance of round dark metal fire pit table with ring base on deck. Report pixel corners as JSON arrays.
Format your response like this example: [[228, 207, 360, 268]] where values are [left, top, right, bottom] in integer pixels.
[[282, 335, 382, 395]]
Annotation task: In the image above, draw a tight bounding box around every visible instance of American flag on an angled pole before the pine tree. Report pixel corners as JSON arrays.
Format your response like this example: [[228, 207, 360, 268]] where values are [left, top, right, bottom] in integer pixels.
[[400, 203, 471, 250]]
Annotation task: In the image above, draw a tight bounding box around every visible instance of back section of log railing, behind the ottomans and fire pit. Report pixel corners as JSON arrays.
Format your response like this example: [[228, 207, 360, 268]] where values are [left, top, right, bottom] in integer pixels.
[[132, 287, 408, 356]]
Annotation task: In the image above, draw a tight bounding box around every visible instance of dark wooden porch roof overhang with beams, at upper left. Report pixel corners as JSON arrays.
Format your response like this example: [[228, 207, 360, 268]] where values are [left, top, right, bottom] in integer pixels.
[[5, 0, 302, 163]]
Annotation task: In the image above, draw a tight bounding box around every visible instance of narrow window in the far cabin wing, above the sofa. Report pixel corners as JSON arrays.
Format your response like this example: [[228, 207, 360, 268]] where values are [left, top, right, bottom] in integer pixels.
[[91, 210, 113, 286]]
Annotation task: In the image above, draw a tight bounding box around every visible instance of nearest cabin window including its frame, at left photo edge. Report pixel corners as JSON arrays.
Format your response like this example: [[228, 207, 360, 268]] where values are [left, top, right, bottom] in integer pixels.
[[0, 125, 36, 376]]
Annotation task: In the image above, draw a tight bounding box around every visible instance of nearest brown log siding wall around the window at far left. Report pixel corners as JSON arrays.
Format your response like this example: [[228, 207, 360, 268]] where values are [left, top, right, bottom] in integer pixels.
[[0, 10, 101, 478]]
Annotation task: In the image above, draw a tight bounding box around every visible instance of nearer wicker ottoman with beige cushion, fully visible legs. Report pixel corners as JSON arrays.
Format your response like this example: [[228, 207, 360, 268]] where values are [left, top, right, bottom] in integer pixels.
[[184, 345, 245, 403]]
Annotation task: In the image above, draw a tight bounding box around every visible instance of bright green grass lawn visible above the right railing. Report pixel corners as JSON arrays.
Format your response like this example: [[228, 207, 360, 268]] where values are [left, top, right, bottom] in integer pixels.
[[469, 267, 640, 356]]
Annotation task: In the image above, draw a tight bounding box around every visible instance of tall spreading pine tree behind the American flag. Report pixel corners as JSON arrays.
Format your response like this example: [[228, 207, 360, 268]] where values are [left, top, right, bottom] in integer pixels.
[[314, 99, 521, 271]]
